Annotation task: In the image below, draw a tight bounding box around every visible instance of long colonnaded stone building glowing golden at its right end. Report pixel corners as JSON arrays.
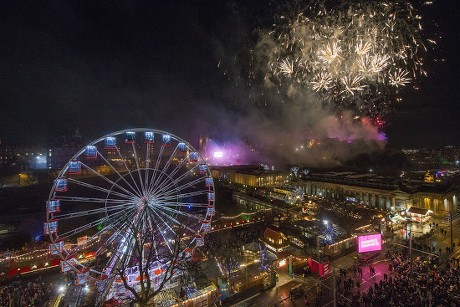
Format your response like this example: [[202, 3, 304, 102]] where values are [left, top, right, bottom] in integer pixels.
[[297, 172, 460, 216]]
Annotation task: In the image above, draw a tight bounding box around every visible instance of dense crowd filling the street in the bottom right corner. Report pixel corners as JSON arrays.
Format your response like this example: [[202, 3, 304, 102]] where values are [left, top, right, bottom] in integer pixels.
[[337, 252, 460, 307]]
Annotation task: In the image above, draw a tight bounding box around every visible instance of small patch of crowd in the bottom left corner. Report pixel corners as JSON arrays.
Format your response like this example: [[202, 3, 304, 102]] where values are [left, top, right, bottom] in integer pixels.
[[0, 277, 53, 307]]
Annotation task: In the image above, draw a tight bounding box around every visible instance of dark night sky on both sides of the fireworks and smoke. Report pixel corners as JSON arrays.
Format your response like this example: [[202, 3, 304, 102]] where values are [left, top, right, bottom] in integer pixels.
[[0, 0, 460, 146]]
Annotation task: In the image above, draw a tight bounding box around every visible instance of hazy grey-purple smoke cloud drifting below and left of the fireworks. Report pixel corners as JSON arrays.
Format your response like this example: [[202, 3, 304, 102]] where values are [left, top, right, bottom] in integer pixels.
[[205, 2, 386, 167]]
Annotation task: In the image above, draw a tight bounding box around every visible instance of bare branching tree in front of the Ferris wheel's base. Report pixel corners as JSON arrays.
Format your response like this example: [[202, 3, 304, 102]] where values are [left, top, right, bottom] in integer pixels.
[[107, 215, 196, 306]]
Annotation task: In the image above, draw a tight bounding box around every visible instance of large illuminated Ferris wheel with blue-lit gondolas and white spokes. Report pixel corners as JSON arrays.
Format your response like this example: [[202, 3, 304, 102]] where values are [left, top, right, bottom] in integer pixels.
[[44, 128, 215, 282]]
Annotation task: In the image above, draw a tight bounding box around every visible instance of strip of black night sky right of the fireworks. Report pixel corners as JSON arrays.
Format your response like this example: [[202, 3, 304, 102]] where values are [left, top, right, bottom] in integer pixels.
[[386, 0, 460, 147]]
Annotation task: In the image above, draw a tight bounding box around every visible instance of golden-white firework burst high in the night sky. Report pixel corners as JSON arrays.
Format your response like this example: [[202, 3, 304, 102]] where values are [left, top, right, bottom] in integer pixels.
[[256, 0, 435, 116]]
